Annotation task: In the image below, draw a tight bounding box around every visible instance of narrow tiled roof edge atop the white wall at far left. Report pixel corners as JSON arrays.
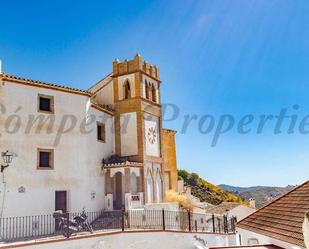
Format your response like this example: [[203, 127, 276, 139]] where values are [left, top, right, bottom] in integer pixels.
[[0, 73, 91, 96]]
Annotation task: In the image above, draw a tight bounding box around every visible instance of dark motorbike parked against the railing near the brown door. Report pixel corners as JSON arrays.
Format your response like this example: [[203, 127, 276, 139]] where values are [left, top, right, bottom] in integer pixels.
[[53, 209, 93, 238]]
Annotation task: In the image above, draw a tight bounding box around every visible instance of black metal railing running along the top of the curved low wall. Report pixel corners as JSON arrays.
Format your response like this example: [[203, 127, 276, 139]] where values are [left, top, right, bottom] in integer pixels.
[[0, 209, 236, 241]]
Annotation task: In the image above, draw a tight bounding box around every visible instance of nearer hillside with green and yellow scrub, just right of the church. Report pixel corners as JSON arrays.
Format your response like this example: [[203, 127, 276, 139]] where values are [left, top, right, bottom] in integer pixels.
[[178, 170, 247, 205]]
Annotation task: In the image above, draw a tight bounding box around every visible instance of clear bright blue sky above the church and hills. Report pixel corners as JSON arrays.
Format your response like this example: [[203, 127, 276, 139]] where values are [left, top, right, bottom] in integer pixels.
[[0, 0, 309, 186]]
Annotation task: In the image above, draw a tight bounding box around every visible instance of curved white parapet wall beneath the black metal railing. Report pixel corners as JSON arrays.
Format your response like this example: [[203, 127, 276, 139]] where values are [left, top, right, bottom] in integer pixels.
[[4, 231, 236, 249]]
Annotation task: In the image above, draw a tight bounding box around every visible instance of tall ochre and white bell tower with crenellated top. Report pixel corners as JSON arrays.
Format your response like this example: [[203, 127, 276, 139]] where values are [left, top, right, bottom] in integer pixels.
[[112, 54, 164, 203]]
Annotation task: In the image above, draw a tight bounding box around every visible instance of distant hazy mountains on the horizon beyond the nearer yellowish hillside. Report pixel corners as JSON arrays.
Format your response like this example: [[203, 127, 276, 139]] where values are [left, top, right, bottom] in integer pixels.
[[218, 184, 294, 208]]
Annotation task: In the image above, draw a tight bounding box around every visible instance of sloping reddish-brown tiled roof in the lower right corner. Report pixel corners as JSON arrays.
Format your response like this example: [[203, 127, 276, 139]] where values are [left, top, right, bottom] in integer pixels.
[[237, 181, 309, 247]]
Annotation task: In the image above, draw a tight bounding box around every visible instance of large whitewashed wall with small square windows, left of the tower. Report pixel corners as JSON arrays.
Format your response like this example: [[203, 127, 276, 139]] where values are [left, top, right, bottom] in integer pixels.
[[0, 80, 114, 217]]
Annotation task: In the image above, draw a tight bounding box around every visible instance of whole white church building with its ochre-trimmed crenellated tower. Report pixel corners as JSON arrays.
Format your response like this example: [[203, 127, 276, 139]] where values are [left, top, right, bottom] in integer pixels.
[[0, 54, 177, 217]]
